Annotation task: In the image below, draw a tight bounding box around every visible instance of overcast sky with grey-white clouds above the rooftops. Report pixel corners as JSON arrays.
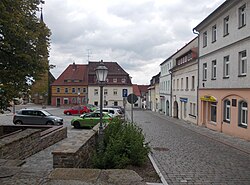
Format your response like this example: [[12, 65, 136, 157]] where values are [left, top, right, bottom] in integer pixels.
[[43, 0, 224, 84]]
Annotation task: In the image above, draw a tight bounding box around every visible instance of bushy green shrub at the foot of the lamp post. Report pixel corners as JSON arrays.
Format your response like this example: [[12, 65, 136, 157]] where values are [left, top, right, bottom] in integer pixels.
[[92, 119, 150, 169]]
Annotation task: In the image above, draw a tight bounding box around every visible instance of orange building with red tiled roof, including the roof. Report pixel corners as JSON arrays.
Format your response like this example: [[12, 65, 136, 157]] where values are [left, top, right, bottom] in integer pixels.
[[51, 63, 88, 106]]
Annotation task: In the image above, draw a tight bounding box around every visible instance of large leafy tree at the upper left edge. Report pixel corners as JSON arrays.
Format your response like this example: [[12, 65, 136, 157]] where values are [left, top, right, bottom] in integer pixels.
[[0, 0, 50, 104]]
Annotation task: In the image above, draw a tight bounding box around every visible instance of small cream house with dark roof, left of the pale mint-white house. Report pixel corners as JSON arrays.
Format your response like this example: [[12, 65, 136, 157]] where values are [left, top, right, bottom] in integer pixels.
[[147, 73, 161, 112]]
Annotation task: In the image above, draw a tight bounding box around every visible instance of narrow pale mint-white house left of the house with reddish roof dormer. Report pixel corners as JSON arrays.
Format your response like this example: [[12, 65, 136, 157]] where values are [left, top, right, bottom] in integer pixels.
[[159, 56, 173, 116]]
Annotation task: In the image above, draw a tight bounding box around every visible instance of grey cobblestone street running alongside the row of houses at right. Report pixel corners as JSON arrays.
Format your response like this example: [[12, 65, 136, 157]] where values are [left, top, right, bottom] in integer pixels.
[[134, 111, 250, 185]]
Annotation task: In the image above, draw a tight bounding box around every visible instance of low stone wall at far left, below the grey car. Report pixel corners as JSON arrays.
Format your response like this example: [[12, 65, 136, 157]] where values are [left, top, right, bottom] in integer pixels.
[[0, 127, 67, 159]]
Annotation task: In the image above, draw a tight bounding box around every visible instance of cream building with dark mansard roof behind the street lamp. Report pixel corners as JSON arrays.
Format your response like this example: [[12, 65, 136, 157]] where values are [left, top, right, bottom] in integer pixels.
[[88, 62, 132, 106]]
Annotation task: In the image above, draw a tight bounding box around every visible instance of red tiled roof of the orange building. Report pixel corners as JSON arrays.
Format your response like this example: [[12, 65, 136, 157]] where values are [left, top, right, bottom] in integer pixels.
[[52, 63, 88, 85]]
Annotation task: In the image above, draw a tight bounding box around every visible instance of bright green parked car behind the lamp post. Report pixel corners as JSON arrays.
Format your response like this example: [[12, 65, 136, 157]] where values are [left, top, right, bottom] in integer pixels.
[[71, 112, 112, 128]]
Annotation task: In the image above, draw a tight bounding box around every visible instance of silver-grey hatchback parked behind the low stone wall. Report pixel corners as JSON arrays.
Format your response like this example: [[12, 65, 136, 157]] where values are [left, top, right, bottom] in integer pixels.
[[13, 109, 63, 125]]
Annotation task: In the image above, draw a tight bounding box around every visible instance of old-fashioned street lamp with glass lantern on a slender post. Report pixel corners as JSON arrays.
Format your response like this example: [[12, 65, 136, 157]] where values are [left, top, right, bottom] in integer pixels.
[[95, 60, 108, 134]]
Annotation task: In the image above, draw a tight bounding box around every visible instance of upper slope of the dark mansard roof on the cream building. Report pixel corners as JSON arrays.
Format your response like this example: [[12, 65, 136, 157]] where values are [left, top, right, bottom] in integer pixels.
[[89, 61, 128, 75]]
